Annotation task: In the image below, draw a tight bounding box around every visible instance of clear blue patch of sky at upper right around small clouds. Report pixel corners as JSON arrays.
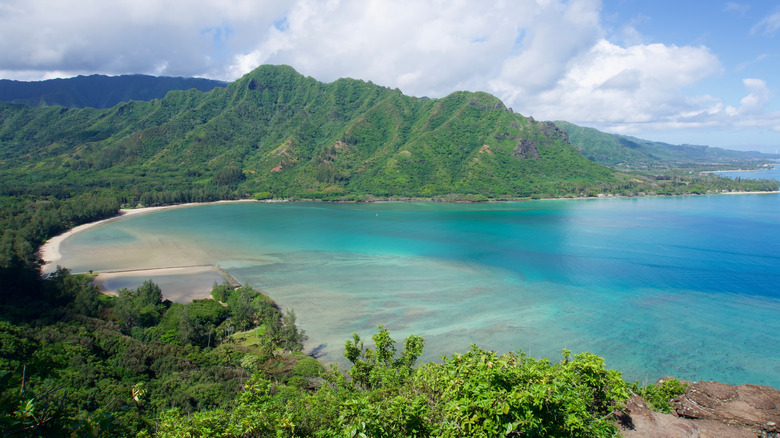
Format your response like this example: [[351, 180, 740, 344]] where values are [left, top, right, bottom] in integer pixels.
[[602, 0, 780, 152]]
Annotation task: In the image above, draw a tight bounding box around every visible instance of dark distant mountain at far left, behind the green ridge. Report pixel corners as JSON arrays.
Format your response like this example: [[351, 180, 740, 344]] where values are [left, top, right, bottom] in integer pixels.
[[0, 75, 226, 108]]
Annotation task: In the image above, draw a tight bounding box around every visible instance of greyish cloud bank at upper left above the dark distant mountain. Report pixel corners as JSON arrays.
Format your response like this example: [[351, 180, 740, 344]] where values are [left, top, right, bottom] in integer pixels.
[[0, 0, 286, 76]]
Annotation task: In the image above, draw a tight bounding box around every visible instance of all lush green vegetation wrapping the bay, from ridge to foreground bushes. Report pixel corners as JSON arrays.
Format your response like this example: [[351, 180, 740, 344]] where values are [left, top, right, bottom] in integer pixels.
[[0, 66, 778, 436]]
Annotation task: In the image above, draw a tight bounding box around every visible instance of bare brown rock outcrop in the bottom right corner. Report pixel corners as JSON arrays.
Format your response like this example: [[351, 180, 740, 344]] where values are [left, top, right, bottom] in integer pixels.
[[617, 382, 780, 438]]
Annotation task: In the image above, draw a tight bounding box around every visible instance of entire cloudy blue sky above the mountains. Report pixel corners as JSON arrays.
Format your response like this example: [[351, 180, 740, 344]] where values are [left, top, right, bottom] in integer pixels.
[[0, 0, 780, 153]]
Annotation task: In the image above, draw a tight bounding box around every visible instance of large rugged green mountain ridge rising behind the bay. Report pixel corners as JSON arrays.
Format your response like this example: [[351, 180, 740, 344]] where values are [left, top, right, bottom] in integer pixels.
[[0, 66, 622, 198]]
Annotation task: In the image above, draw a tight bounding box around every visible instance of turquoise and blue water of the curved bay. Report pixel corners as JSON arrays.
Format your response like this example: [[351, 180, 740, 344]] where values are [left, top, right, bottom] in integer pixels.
[[60, 194, 780, 388]]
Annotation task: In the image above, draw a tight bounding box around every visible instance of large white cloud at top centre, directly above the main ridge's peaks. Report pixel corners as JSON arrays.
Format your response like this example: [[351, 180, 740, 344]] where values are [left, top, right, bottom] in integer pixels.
[[229, 0, 544, 96]]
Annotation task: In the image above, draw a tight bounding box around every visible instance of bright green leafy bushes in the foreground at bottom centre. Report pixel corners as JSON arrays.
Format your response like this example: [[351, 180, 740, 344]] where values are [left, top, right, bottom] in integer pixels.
[[159, 327, 629, 437]]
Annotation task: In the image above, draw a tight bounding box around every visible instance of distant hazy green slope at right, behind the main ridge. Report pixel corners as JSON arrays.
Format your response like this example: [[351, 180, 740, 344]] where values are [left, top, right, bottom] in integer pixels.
[[555, 121, 780, 169]]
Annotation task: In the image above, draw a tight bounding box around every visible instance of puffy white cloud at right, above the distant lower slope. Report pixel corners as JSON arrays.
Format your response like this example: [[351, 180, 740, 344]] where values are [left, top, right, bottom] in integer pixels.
[[508, 40, 721, 124]]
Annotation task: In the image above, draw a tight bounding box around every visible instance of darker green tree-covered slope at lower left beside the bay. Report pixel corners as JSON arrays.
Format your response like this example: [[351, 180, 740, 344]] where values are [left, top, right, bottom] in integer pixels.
[[0, 270, 310, 436]]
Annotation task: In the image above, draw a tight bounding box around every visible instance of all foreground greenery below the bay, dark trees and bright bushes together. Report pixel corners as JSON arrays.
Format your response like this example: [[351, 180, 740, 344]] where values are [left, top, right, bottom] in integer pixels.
[[0, 276, 630, 437]]
